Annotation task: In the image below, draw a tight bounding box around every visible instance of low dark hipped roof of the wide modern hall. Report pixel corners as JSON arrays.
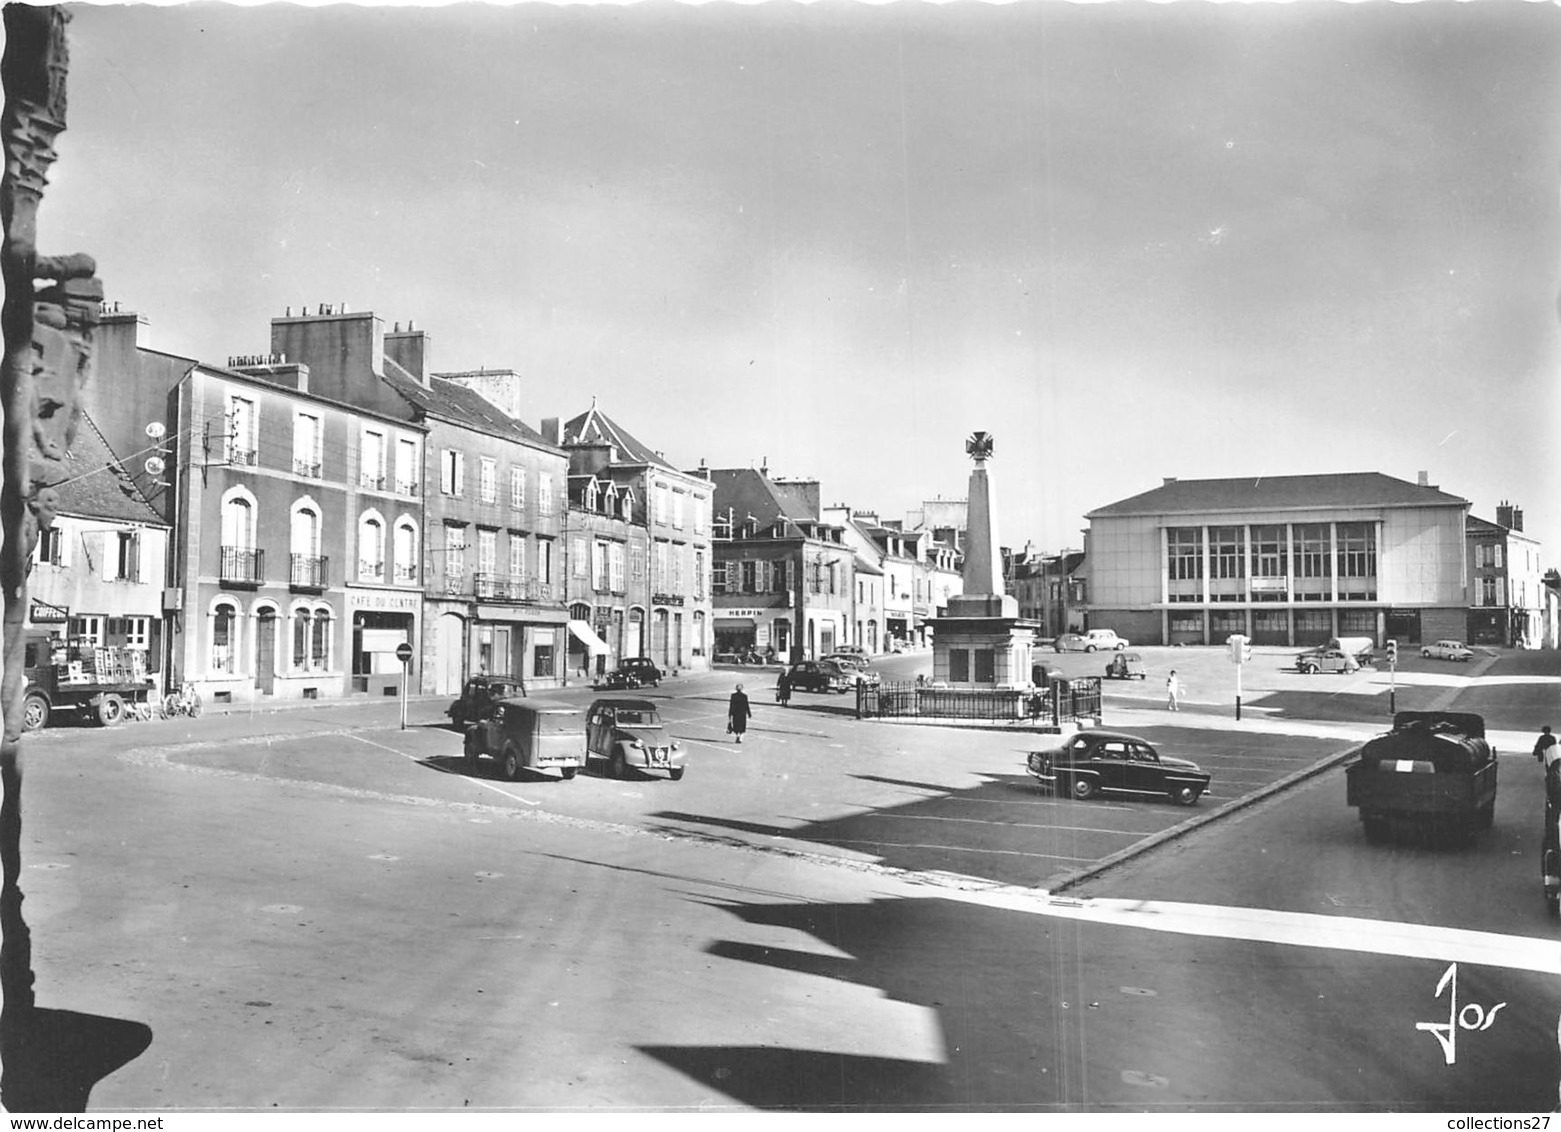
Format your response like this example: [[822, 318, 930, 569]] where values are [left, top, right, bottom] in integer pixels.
[[1085, 472, 1469, 518]]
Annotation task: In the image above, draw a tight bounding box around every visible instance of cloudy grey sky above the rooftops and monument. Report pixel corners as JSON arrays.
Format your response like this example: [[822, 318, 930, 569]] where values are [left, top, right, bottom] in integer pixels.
[[30, 0, 1561, 564]]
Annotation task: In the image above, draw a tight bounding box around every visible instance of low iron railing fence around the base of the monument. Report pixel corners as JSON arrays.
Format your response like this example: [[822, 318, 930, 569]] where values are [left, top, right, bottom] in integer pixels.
[[857, 676, 1101, 726]]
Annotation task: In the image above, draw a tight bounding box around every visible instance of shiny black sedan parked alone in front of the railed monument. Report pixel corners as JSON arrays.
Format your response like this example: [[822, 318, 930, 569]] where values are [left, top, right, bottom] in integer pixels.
[[1029, 731, 1210, 806]]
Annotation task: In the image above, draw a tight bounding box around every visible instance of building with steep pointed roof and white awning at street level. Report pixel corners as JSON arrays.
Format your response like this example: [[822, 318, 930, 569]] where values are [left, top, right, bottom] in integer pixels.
[[542, 403, 715, 671]]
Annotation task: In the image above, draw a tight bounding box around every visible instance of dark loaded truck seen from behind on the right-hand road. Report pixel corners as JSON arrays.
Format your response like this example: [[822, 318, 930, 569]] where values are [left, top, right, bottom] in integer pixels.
[[1344, 712, 1495, 842]]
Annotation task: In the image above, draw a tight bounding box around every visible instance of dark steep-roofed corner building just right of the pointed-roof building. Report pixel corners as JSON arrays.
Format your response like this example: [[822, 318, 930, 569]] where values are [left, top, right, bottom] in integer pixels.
[[707, 468, 855, 660]]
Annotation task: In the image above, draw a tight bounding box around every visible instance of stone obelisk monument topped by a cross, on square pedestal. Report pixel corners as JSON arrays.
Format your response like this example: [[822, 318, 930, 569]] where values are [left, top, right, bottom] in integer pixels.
[[932, 433, 1040, 690]]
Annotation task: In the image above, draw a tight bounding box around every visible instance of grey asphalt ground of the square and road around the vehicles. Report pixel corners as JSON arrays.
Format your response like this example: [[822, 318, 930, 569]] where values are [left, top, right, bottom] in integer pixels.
[[12, 650, 1556, 1112]]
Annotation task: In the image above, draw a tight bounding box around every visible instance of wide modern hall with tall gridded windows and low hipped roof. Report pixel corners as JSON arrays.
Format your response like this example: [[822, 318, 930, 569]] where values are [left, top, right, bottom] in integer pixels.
[[1085, 472, 1469, 645]]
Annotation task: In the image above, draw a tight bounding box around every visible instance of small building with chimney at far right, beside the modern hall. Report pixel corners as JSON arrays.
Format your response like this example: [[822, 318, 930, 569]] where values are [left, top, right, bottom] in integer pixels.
[[1464, 500, 1545, 648]]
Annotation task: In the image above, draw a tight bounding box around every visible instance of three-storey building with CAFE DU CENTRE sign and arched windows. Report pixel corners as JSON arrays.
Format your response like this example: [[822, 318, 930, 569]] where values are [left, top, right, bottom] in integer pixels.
[[84, 306, 423, 704]]
